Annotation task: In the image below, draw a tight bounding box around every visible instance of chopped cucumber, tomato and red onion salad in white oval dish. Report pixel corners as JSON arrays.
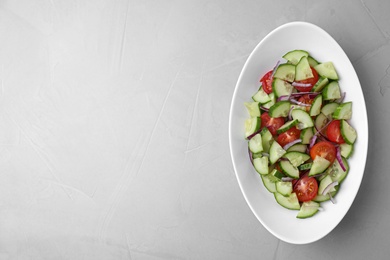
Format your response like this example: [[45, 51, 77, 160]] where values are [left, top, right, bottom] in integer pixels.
[[244, 50, 357, 218]]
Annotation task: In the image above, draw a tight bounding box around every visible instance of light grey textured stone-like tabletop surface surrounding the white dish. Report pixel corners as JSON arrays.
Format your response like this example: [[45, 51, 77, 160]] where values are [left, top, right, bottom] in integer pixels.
[[0, 0, 390, 259]]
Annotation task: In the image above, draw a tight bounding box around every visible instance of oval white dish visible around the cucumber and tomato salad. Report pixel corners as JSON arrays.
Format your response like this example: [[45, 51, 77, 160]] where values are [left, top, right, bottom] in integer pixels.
[[229, 22, 368, 244]]
